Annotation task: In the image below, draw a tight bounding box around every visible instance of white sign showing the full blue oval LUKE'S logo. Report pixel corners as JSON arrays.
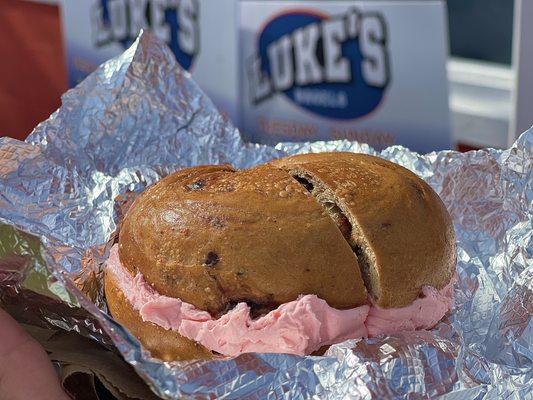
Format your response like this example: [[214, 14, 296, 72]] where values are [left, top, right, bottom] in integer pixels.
[[240, 0, 451, 152]]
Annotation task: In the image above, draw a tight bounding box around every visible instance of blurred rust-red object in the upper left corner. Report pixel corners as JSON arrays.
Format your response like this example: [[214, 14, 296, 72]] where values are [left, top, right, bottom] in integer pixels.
[[0, 0, 68, 140]]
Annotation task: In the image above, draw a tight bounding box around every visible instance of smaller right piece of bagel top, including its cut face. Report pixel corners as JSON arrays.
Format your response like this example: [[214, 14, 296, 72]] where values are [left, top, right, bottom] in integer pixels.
[[271, 152, 456, 308]]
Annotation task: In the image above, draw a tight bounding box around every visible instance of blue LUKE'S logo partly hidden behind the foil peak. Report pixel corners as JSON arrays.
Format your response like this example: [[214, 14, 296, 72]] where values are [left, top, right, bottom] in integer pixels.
[[91, 0, 199, 70]]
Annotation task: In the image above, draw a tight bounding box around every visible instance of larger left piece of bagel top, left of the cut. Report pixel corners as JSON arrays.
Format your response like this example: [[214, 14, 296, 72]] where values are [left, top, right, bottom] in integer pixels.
[[119, 165, 366, 316]]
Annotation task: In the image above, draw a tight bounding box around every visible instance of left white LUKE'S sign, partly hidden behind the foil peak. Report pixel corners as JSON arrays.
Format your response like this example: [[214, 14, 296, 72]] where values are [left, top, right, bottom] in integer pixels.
[[62, 0, 238, 122]]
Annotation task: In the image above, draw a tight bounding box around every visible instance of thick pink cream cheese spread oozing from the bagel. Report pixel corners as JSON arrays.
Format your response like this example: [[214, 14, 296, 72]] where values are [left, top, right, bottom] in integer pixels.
[[106, 246, 453, 356]]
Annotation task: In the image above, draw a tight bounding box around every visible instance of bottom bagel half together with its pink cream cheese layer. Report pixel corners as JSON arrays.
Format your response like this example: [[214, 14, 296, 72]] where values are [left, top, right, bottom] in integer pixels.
[[105, 246, 453, 361]]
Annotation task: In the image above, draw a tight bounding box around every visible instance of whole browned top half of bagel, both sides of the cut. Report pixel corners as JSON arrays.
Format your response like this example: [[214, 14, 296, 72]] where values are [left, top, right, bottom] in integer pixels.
[[119, 153, 456, 316]]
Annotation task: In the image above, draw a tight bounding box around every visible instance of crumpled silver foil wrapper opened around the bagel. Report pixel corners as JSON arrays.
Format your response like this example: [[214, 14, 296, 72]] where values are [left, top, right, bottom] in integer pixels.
[[0, 33, 533, 399]]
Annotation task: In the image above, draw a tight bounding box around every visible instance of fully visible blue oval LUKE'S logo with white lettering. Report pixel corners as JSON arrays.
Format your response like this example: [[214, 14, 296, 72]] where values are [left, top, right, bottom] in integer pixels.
[[249, 9, 390, 120]]
